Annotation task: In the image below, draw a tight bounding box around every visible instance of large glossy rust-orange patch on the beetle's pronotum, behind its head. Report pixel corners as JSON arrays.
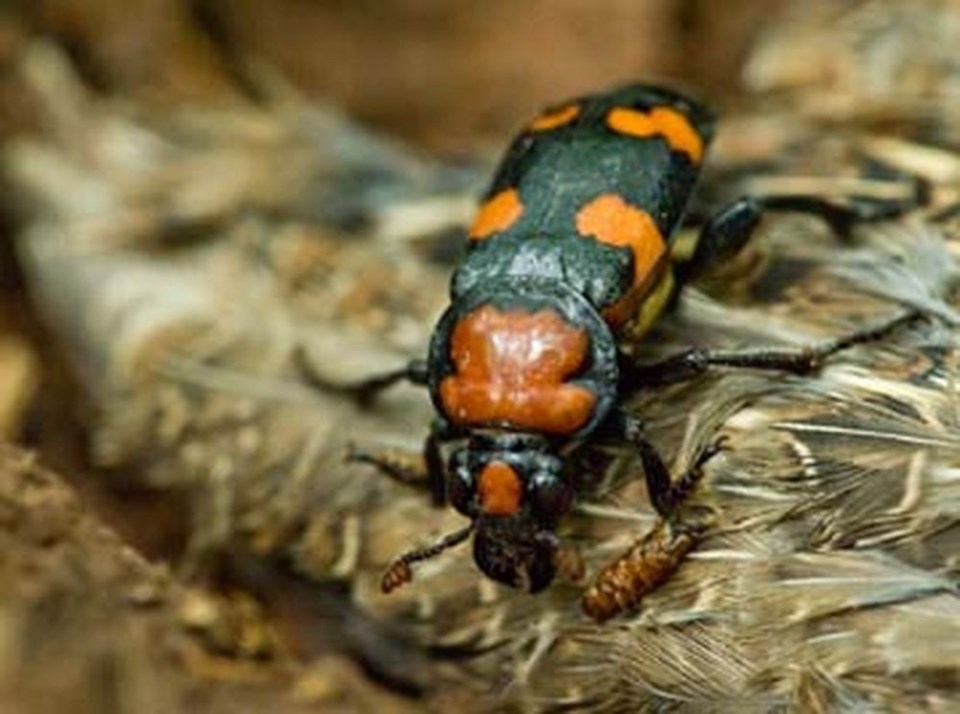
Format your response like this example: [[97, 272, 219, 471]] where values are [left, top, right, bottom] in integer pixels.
[[440, 305, 596, 434]]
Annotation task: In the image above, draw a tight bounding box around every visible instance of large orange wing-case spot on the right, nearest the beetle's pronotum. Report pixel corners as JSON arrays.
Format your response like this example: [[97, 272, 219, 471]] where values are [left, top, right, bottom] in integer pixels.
[[576, 193, 667, 286]]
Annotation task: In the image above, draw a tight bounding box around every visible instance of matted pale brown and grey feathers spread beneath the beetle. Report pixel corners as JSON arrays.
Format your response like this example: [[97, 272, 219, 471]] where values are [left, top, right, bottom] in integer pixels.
[[5, 9, 960, 712]]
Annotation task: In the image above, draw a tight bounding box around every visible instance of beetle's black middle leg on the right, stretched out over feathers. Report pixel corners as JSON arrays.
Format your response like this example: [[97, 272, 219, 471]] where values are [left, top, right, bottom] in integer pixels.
[[621, 309, 924, 384]]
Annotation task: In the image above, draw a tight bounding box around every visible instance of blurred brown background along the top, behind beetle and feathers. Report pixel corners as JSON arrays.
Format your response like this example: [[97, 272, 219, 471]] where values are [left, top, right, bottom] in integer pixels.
[[0, 0, 784, 154]]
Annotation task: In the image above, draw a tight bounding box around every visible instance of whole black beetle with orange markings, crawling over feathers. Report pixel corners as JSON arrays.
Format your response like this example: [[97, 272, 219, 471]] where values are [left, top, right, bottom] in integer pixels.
[[334, 84, 920, 619]]
